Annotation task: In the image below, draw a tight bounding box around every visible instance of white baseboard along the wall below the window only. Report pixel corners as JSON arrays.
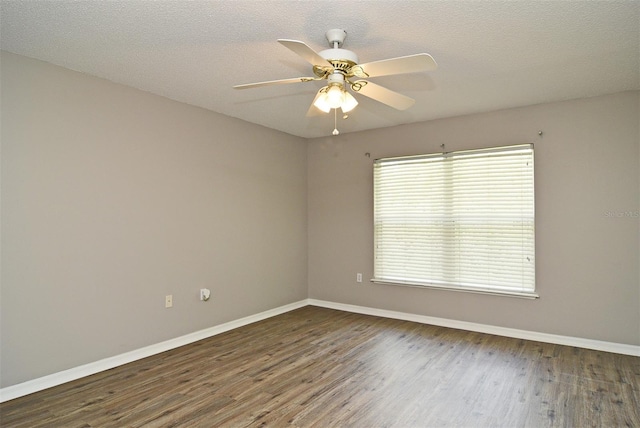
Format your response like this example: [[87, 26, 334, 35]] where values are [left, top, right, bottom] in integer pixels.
[[308, 299, 640, 357]]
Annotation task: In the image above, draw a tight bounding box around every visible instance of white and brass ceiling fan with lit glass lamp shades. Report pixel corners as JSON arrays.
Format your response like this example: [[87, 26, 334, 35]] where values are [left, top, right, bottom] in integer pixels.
[[234, 29, 437, 116]]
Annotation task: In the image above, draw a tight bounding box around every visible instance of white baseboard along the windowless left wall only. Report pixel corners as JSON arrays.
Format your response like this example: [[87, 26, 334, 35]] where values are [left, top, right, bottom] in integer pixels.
[[0, 299, 309, 403]]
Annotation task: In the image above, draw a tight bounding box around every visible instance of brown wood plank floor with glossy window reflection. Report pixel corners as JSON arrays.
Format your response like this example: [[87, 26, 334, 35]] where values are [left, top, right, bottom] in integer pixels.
[[0, 306, 640, 427]]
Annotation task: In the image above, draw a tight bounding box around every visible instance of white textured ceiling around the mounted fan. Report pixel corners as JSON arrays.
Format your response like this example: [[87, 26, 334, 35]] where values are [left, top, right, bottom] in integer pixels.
[[0, 0, 640, 137]]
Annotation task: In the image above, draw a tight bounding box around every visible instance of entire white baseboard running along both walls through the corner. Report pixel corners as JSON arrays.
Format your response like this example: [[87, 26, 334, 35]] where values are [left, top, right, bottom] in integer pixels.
[[0, 299, 640, 403]]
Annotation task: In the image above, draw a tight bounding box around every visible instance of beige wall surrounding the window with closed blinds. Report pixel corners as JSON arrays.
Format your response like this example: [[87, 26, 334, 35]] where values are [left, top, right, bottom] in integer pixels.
[[308, 91, 640, 345]]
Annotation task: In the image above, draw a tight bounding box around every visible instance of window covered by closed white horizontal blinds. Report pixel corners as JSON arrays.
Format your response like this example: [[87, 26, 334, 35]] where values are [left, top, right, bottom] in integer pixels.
[[373, 144, 537, 297]]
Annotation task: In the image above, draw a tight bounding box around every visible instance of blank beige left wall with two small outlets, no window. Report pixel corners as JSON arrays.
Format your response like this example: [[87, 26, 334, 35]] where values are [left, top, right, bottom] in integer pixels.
[[0, 53, 307, 387]]
